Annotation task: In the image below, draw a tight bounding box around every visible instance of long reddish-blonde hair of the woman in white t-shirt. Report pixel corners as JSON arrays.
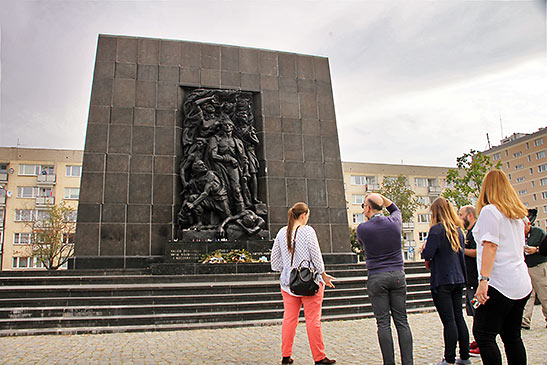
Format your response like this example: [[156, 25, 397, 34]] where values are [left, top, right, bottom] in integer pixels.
[[477, 170, 528, 219]]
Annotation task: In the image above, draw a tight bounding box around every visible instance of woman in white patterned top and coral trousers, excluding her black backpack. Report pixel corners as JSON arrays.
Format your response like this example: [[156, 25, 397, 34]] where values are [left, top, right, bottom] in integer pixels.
[[271, 203, 336, 364]]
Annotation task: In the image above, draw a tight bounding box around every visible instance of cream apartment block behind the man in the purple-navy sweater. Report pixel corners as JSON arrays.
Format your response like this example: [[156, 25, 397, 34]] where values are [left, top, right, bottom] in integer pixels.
[[342, 162, 449, 261]]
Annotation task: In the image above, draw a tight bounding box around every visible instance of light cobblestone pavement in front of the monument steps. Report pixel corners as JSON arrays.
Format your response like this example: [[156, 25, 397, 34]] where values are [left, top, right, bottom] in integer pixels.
[[0, 306, 547, 365]]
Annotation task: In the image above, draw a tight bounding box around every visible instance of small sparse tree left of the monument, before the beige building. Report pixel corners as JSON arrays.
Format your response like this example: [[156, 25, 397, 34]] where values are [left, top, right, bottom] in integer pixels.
[[30, 202, 76, 270]]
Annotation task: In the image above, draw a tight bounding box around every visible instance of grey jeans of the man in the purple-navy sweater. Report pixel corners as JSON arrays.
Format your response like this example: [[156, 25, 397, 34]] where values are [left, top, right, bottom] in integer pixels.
[[367, 271, 414, 365]]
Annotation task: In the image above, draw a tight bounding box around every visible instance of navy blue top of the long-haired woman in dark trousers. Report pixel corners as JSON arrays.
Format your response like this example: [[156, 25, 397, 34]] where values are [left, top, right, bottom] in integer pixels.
[[422, 223, 466, 290]]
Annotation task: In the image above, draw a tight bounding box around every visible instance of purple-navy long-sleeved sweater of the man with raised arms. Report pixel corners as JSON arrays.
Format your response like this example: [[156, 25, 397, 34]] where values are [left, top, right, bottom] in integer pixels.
[[357, 203, 403, 275]]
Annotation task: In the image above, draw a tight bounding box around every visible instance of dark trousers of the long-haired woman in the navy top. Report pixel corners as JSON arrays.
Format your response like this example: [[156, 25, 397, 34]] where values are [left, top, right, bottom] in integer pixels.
[[431, 284, 470, 363]]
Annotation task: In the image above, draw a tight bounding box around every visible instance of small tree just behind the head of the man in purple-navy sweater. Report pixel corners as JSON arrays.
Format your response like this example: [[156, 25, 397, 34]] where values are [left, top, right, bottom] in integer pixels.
[[380, 175, 421, 223]]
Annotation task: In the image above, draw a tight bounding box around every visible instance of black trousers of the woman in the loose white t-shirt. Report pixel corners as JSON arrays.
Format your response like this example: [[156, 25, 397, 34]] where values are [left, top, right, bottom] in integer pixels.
[[473, 287, 530, 365]]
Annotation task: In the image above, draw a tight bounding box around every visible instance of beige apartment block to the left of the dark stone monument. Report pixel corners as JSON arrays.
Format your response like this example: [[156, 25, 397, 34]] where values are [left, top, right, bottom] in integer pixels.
[[0, 147, 83, 270]]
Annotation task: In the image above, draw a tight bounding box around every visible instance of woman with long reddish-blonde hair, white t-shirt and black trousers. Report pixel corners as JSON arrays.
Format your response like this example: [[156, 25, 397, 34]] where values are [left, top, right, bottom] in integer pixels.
[[473, 170, 532, 365]]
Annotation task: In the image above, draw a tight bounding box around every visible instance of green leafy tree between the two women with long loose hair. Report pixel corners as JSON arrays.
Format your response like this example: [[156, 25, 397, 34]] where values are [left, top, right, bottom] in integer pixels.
[[443, 149, 501, 207]]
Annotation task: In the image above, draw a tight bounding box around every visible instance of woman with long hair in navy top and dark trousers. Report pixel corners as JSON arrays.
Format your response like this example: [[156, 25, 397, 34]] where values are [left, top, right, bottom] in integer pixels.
[[422, 198, 471, 365]]
